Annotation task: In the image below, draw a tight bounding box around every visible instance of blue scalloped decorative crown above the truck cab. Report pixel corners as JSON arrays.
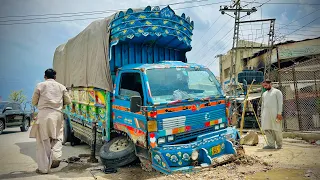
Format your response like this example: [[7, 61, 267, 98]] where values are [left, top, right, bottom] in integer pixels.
[[110, 6, 194, 51]]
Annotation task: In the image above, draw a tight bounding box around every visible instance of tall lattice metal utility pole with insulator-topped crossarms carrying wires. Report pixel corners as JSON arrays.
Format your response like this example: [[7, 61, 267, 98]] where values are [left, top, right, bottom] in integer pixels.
[[220, 0, 257, 97]]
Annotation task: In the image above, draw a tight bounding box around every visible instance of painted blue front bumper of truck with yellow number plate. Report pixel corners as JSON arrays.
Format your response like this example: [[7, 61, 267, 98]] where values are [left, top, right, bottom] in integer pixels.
[[151, 127, 239, 174]]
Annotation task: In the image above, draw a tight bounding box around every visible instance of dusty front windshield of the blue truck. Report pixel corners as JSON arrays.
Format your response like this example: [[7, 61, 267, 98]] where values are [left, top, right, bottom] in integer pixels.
[[146, 68, 222, 103]]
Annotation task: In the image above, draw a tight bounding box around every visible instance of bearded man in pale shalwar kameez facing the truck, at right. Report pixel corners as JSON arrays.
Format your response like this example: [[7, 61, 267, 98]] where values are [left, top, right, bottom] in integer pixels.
[[261, 79, 283, 149]]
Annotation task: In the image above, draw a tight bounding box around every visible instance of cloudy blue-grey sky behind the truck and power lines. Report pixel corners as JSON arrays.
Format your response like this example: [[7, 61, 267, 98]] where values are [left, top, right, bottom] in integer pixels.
[[0, 0, 320, 100]]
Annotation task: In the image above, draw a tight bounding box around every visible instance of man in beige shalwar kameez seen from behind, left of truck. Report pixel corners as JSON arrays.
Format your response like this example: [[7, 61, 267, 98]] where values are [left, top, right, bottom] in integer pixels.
[[30, 69, 71, 174]]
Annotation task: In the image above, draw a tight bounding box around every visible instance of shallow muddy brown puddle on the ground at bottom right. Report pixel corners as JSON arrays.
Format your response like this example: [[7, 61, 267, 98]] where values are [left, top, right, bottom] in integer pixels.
[[246, 169, 307, 180]]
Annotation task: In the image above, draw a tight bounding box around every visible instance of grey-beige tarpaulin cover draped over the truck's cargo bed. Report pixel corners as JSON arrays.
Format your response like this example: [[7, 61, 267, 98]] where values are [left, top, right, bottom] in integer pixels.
[[53, 15, 114, 92]]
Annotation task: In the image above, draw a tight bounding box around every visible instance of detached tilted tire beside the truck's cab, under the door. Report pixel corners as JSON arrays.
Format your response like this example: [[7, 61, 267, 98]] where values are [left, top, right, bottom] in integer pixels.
[[99, 136, 137, 168]]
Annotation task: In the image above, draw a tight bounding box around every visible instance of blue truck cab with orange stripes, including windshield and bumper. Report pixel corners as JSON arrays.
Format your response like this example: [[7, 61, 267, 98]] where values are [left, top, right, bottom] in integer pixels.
[[112, 61, 238, 173]]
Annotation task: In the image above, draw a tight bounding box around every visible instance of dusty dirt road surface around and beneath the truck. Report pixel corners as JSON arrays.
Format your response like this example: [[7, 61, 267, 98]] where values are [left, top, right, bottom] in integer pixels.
[[0, 128, 320, 180]]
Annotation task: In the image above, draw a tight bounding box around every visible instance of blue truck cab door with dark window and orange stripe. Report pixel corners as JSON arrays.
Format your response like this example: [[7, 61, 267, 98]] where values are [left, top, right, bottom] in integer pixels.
[[113, 71, 147, 147]]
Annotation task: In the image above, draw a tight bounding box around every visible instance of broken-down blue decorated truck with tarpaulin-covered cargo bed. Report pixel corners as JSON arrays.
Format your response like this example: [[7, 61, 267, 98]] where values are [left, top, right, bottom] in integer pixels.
[[53, 6, 241, 174]]
